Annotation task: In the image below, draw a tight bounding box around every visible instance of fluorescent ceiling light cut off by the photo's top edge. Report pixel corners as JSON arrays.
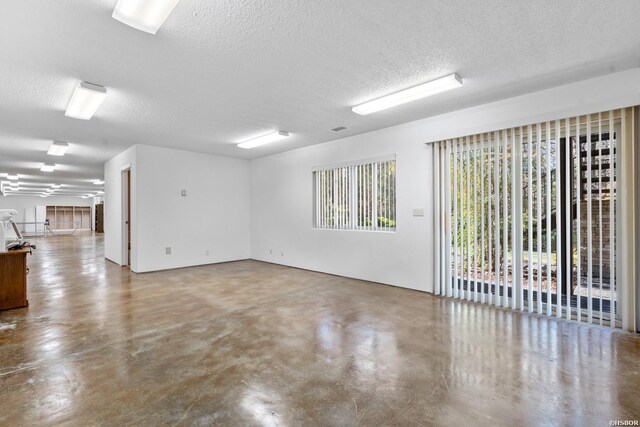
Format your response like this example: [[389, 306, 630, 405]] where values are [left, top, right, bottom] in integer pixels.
[[111, 0, 180, 34]]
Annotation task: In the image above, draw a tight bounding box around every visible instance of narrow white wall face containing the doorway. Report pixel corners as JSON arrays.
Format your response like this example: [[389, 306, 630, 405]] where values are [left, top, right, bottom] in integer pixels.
[[104, 146, 138, 265]]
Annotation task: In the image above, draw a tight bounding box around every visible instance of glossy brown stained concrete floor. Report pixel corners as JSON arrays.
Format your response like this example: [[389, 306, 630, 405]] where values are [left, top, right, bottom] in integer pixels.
[[0, 235, 640, 426]]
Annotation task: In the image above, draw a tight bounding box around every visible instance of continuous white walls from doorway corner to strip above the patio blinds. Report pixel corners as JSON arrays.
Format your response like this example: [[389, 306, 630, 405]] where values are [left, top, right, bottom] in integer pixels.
[[105, 68, 640, 284]]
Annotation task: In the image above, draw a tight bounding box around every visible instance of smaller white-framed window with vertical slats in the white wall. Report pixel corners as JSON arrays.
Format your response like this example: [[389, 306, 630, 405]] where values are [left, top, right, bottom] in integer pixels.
[[313, 156, 396, 231]]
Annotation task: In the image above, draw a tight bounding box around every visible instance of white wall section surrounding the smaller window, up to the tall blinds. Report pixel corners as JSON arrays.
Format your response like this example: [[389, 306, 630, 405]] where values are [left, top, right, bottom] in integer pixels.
[[251, 137, 431, 290]]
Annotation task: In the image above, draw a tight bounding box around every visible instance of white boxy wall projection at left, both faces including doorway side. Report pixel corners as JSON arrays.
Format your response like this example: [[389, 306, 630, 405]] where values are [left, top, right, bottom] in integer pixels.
[[105, 145, 249, 272]]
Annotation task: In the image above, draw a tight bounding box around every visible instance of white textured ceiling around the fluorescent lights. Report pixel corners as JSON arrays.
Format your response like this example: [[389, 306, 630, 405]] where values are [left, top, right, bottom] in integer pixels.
[[0, 0, 640, 196]]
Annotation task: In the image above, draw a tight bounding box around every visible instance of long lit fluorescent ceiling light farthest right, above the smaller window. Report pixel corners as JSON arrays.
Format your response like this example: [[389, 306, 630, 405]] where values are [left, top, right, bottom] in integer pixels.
[[351, 74, 462, 116]]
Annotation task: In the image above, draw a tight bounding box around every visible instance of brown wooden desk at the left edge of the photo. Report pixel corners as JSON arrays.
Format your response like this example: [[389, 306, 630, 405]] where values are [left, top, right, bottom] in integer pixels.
[[0, 248, 29, 310]]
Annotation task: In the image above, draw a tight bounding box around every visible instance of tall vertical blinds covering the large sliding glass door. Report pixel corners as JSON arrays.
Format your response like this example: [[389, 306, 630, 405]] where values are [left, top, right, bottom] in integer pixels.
[[433, 109, 635, 329]]
